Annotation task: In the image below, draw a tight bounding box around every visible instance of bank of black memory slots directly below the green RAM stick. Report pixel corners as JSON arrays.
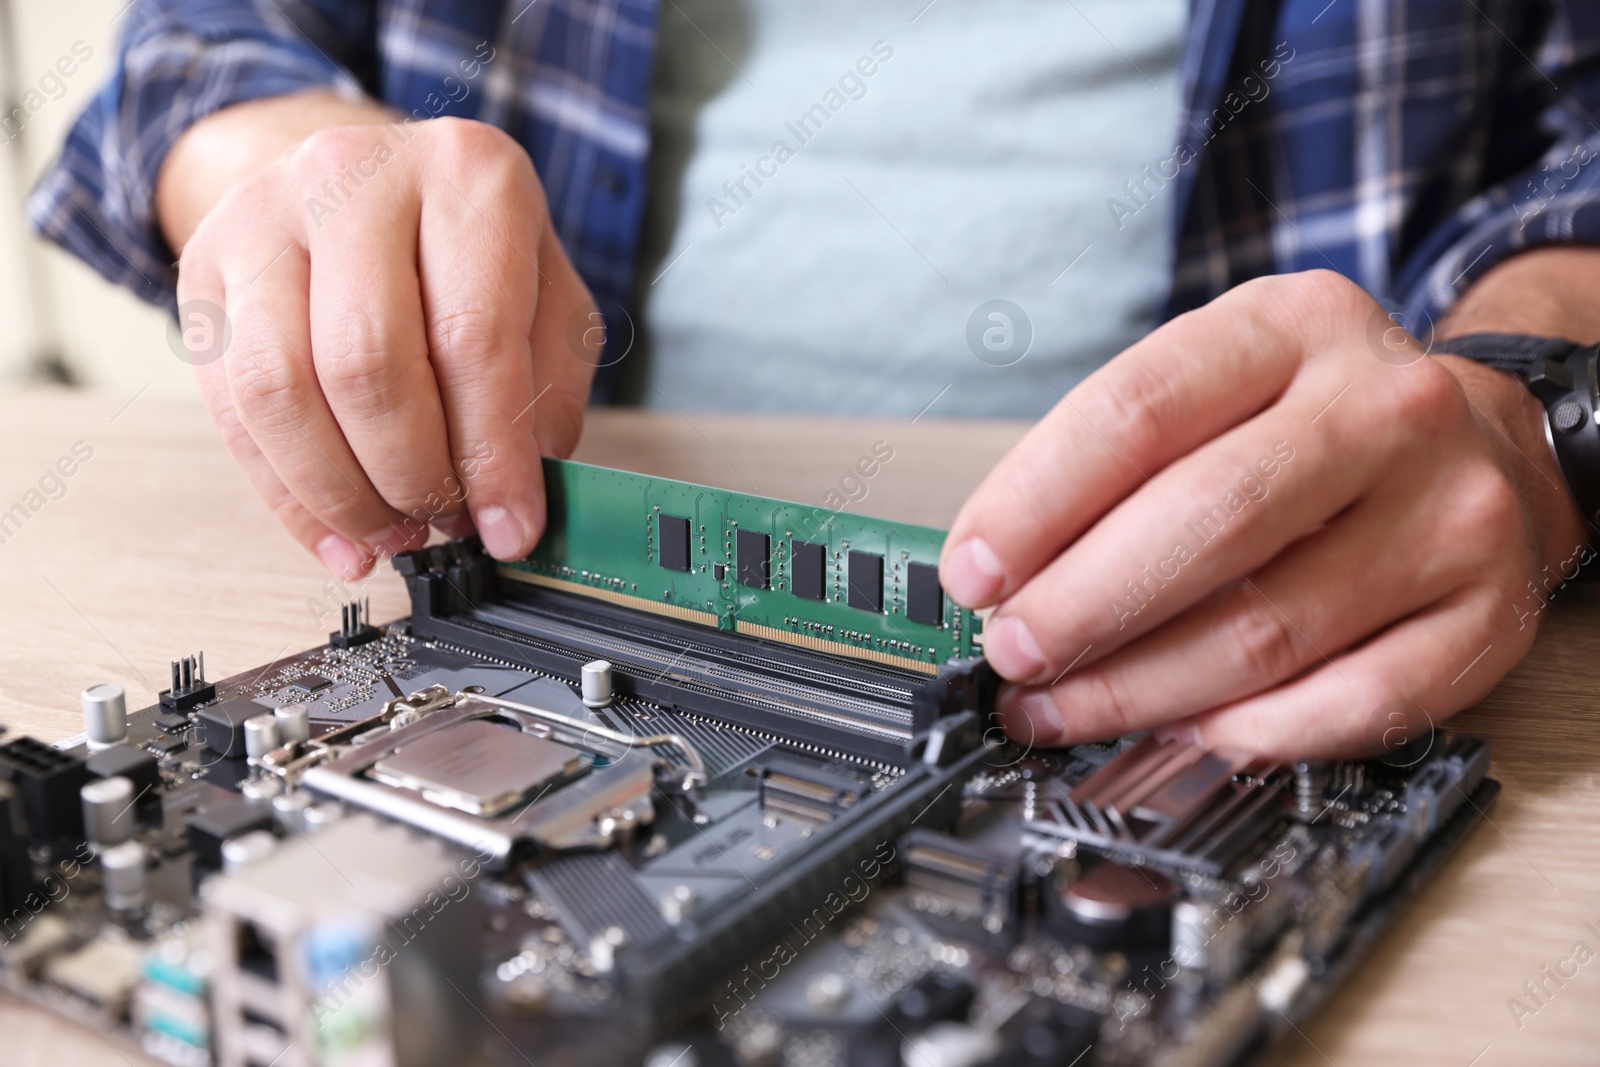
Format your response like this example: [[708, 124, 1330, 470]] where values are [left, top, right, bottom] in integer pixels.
[[397, 545, 987, 766]]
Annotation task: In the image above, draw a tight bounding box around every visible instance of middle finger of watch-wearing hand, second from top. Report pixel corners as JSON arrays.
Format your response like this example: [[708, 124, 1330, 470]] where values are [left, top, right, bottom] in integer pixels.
[[984, 350, 1470, 683]]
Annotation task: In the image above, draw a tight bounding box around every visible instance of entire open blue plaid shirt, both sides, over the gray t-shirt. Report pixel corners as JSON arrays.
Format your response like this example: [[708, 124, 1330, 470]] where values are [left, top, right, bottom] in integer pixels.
[[29, 0, 1600, 361]]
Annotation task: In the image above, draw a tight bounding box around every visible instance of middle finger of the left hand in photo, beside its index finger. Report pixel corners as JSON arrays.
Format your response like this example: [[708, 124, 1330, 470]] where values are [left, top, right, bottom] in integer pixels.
[[307, 126, 464, 537]]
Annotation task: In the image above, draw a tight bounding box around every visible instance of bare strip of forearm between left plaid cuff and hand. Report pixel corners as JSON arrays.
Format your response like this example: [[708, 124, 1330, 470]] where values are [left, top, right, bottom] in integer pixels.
[[155, 90, 398, 253]]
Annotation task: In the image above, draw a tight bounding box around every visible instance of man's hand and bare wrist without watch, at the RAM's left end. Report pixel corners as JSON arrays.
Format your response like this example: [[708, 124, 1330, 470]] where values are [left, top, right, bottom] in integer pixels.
[[158, 94, 600, 577]]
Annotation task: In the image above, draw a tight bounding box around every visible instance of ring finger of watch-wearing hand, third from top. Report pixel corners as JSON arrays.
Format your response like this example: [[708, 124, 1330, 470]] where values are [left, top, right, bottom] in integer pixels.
[[1000, 482, 1475, 744]]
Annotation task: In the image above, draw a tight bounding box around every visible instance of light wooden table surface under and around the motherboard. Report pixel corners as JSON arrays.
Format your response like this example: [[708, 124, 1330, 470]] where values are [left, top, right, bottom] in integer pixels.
[[0, 390, 1600, 1067]]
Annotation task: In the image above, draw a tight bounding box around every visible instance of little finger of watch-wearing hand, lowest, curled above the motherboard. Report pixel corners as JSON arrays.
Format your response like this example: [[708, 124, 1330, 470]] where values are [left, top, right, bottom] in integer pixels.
[[1182, 585, 1534, 758]]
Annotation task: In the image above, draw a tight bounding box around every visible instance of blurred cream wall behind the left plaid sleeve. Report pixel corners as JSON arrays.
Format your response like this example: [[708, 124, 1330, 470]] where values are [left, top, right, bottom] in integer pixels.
[[0, 0, 195, 395]]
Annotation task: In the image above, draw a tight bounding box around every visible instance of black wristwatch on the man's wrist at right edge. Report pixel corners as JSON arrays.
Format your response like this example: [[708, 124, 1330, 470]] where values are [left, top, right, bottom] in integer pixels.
[[1432, 333, 1600, 581]]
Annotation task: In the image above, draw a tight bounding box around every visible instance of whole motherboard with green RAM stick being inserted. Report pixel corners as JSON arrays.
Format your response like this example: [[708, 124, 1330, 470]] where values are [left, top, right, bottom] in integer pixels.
[[0, 461, 1499, 1067]]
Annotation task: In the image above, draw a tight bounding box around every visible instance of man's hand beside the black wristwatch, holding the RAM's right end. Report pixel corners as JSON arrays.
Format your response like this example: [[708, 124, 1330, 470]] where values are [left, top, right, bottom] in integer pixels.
[[941, 261, 1587, 757]]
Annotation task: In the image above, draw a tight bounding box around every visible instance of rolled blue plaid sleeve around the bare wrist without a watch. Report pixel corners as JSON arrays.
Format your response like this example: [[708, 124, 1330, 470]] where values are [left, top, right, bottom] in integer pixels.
[[27, 0, 373, 309]]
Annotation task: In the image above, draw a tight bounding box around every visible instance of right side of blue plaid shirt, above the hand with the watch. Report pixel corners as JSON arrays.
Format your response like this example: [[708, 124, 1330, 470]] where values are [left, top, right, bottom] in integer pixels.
[[1163, 0, 1600, 336]]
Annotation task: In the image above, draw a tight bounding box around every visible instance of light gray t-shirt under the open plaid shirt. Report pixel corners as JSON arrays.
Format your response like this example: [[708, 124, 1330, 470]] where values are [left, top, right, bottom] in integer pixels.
[[624, 0, 1187, 416]]
